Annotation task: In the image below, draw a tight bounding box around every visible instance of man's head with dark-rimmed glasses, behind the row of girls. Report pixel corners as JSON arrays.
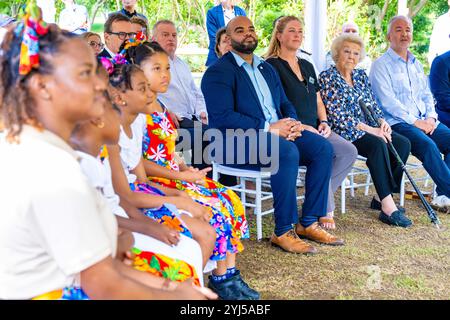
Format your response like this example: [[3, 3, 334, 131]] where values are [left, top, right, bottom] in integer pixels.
[[98, 13, 136, 58]]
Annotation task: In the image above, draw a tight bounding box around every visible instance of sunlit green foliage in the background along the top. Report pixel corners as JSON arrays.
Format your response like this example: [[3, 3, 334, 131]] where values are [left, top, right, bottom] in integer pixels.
[[0, 0, 448, 71]]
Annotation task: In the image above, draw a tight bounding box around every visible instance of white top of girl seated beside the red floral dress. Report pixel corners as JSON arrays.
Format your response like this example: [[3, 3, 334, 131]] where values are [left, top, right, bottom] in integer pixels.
[[119, 114, 147, 183]]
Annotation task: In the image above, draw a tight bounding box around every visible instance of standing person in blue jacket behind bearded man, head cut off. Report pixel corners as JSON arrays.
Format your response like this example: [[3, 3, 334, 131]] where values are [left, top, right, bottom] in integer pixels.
[[206, 0, 246, 67]]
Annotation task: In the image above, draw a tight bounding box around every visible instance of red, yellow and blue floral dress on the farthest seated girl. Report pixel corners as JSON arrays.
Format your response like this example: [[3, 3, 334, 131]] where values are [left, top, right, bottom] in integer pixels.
[[142, 107, 249, 261]]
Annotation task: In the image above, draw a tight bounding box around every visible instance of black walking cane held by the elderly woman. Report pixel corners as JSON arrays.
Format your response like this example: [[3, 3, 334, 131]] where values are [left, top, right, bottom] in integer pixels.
[[358, 98, 441, 229]]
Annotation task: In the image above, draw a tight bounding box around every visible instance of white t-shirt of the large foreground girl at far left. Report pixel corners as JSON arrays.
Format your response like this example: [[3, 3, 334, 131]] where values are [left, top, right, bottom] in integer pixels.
[[0, 126, 117, 299]]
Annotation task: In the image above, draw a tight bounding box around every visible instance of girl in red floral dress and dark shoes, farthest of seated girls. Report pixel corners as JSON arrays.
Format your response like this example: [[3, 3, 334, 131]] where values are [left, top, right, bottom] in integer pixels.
[[128, 42, 259, 300]]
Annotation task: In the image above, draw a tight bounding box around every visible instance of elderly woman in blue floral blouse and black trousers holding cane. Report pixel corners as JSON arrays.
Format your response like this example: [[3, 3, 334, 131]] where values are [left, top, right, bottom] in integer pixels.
[[319, 34, 412, 227]]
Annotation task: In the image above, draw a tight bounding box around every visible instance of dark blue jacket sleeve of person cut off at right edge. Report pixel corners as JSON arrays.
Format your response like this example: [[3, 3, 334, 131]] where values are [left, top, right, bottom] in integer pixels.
[[430, 51, 450, 127]]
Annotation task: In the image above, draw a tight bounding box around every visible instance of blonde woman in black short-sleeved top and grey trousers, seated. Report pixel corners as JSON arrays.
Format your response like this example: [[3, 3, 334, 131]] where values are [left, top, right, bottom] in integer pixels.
[[265, 16, 358, 229]]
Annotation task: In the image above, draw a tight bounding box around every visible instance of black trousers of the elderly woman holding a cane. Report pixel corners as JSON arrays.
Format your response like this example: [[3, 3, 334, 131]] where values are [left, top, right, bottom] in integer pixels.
[[353, 132, 411, 200]]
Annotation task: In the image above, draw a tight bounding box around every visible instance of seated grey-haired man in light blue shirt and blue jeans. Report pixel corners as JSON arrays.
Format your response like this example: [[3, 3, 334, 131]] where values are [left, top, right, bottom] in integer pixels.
[[370, 16, 450, 209]]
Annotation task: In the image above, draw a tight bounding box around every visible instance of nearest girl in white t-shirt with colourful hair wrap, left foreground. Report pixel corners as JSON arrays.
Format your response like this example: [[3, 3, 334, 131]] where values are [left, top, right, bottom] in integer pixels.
[[0, 2, 214, 299]]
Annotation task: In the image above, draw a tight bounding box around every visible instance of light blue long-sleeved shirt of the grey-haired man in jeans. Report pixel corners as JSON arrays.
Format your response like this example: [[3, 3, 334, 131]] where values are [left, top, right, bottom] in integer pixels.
[[369, 48, 438, 126]]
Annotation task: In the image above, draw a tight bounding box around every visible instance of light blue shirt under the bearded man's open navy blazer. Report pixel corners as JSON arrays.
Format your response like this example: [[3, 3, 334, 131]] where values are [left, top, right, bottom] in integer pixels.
[[231, 51, 279, 131]]
